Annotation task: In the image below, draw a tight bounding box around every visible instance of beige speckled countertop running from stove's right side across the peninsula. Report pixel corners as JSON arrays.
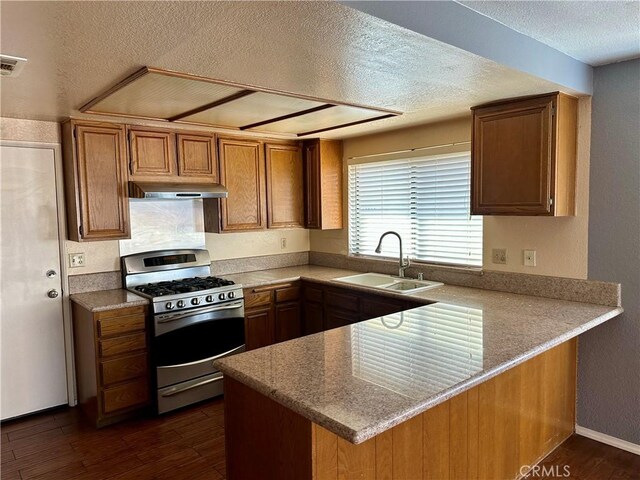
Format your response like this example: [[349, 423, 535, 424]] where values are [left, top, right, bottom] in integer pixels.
[[216, 265, 622, 443]]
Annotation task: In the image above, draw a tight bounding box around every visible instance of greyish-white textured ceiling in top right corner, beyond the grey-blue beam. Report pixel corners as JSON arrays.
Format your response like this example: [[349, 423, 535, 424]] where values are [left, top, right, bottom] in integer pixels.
[[458, 0, 640, 66]]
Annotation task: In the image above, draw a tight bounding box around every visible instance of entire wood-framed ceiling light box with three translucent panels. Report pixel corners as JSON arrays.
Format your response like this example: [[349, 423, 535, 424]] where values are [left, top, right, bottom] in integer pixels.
[[80, 67, 401, 136]]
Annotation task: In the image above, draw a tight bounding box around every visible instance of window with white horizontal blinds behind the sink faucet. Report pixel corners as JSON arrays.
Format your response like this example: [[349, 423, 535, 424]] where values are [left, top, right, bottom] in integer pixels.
[[349, 153, 482, 267]]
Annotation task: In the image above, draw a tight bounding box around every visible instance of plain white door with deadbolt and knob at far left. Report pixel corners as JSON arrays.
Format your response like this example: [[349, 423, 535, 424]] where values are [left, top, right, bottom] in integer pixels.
[[0, 145, 67, 420]]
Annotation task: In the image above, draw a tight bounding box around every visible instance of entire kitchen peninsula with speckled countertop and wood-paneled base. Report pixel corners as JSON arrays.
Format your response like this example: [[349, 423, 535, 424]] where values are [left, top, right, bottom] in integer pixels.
[[216, 275, 622, 480]]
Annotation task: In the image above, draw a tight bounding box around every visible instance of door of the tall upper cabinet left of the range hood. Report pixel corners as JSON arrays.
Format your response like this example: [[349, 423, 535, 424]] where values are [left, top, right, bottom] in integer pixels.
[[74, 124, 129, 240]]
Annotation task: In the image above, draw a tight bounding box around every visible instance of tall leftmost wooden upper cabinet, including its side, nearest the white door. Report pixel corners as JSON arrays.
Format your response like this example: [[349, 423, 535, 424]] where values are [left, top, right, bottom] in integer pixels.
[[62, 121, 130, 242]]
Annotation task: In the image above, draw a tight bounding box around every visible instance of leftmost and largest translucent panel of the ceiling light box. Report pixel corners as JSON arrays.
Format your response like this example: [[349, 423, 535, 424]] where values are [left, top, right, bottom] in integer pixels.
[[81, 72, 243, 120]]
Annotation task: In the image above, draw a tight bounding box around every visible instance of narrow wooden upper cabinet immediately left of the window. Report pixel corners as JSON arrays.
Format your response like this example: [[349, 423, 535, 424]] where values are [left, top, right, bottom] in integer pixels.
[[304, 140, 342, 230]]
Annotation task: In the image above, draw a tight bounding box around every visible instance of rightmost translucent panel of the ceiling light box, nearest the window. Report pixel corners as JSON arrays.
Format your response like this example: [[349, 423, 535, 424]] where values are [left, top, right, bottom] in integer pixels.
[[251, 105, 386, 134]]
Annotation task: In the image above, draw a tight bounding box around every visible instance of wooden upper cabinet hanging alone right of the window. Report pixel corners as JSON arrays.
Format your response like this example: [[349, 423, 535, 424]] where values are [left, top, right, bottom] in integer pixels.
[[471, 92, 578, 216]]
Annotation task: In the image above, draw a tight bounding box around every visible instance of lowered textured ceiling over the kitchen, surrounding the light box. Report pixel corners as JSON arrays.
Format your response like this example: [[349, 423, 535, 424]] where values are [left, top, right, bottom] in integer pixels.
[[0, 0, 560, 138]]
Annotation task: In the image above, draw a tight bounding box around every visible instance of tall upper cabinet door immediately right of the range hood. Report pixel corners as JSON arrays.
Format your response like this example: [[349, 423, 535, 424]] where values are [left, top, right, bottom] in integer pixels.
[[218, 138, 267, 231]]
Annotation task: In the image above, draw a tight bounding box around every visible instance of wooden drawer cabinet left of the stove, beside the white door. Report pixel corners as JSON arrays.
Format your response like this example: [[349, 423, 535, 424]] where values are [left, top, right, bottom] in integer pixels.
[[72, 303, 151, 427]]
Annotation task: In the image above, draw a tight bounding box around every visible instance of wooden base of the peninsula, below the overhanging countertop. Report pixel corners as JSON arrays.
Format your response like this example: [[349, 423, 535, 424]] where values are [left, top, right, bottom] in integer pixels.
[[224, 339, 577, 480]]
